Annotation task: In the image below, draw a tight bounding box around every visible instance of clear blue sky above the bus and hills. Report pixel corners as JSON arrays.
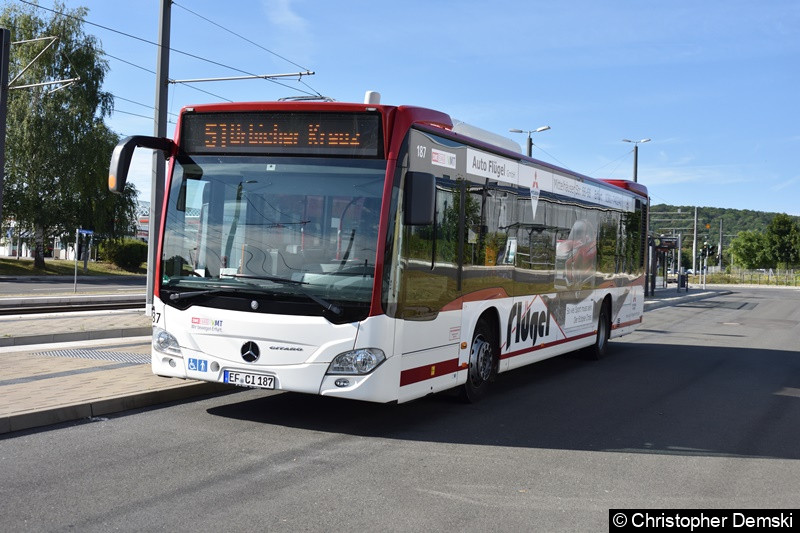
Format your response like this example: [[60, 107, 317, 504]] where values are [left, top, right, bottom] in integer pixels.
[[51, 0, 800, 216]]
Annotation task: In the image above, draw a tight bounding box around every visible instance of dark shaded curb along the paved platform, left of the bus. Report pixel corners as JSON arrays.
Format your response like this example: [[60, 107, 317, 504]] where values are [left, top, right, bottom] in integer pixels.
[[0, 381, 238, 435]]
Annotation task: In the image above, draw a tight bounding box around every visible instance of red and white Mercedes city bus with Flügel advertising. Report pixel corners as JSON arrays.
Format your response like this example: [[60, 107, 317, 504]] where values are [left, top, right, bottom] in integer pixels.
[[109, 92, 648, 402]]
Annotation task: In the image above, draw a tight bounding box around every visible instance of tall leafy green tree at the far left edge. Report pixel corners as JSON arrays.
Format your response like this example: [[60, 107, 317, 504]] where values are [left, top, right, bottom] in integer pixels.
[[0, 2, 136, 268]]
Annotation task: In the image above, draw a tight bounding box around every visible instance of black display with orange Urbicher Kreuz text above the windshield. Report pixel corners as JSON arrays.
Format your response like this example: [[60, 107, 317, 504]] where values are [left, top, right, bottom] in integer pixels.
[[180, 111, 383, 157]]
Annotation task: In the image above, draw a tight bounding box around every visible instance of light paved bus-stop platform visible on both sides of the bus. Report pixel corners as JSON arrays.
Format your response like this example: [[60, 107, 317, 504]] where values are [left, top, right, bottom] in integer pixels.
[[0, 286, 727, 435]]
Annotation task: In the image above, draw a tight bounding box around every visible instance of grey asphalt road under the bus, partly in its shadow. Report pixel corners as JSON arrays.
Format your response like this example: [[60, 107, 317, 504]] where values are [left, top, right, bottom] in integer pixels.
[[0, 290, 800, 532]]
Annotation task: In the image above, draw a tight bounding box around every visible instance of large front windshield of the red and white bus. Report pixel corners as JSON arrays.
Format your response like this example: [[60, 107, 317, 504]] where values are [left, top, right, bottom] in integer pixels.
[[161, 155, 386, 310]]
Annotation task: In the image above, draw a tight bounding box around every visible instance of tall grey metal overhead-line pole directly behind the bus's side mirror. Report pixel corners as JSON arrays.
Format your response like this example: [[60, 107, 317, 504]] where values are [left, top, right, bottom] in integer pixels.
[[145, 0, 172, 316]]
